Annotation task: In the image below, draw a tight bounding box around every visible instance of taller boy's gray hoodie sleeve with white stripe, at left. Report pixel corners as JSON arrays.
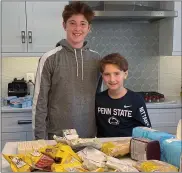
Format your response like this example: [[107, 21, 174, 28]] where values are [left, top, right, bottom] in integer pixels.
[[32, 56, 51, 139]]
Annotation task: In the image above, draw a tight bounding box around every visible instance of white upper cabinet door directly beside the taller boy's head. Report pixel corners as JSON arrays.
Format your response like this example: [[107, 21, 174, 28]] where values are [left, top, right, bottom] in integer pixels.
[[26, 2, 68, 52]]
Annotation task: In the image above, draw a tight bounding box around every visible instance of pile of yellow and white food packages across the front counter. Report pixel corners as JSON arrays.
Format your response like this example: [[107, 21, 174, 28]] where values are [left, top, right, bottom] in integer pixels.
[[3, 129, 181, 172]]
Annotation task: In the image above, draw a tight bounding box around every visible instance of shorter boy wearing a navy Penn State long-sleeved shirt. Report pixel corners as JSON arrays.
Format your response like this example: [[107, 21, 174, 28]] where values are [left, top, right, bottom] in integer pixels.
[[95, 53, 151, 137]]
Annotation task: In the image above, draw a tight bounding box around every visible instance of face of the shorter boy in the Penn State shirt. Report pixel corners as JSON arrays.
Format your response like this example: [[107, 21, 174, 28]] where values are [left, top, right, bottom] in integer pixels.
[[102, 64, 128, 91]]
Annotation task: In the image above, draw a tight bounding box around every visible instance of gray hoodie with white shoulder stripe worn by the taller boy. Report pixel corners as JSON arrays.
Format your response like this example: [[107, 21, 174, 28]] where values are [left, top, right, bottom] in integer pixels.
[[32, 39, 100, 139]]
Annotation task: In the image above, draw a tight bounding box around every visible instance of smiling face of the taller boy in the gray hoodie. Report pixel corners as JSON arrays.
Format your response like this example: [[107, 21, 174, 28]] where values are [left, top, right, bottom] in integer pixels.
[[63, 14, 90, 48]]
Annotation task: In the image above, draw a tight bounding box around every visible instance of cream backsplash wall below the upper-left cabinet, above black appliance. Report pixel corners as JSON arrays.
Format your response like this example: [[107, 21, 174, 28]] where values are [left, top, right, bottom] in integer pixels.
[[1, 57, 39, 97]]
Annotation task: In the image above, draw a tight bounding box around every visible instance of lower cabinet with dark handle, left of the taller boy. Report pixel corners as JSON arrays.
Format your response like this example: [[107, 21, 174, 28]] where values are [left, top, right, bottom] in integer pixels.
[[1, 108, 33, 148]]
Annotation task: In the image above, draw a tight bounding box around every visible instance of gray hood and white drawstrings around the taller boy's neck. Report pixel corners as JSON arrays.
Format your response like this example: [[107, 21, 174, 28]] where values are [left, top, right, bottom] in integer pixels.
[[56, 39, 89, 80]]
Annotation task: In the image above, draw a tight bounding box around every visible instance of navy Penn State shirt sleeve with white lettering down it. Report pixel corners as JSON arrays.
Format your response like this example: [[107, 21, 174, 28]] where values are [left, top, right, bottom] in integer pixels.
[[134, 98, 152, 127]]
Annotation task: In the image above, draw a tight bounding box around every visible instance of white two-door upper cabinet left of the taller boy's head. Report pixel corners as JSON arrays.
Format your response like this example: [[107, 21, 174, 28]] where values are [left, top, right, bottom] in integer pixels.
[[2, 1, 68, 54]]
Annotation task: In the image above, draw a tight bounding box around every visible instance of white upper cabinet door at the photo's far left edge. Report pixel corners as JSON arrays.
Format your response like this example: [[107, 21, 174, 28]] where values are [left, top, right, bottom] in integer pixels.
[[2, 2, 27, 52]]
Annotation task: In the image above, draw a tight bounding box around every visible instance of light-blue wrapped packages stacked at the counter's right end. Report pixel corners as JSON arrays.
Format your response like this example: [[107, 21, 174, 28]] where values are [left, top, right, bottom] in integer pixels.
[[132, 127, 182, 172]]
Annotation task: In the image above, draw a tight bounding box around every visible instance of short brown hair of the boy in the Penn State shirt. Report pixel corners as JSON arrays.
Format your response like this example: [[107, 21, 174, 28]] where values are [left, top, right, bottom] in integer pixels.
[[100, 53, 128, 73]]
